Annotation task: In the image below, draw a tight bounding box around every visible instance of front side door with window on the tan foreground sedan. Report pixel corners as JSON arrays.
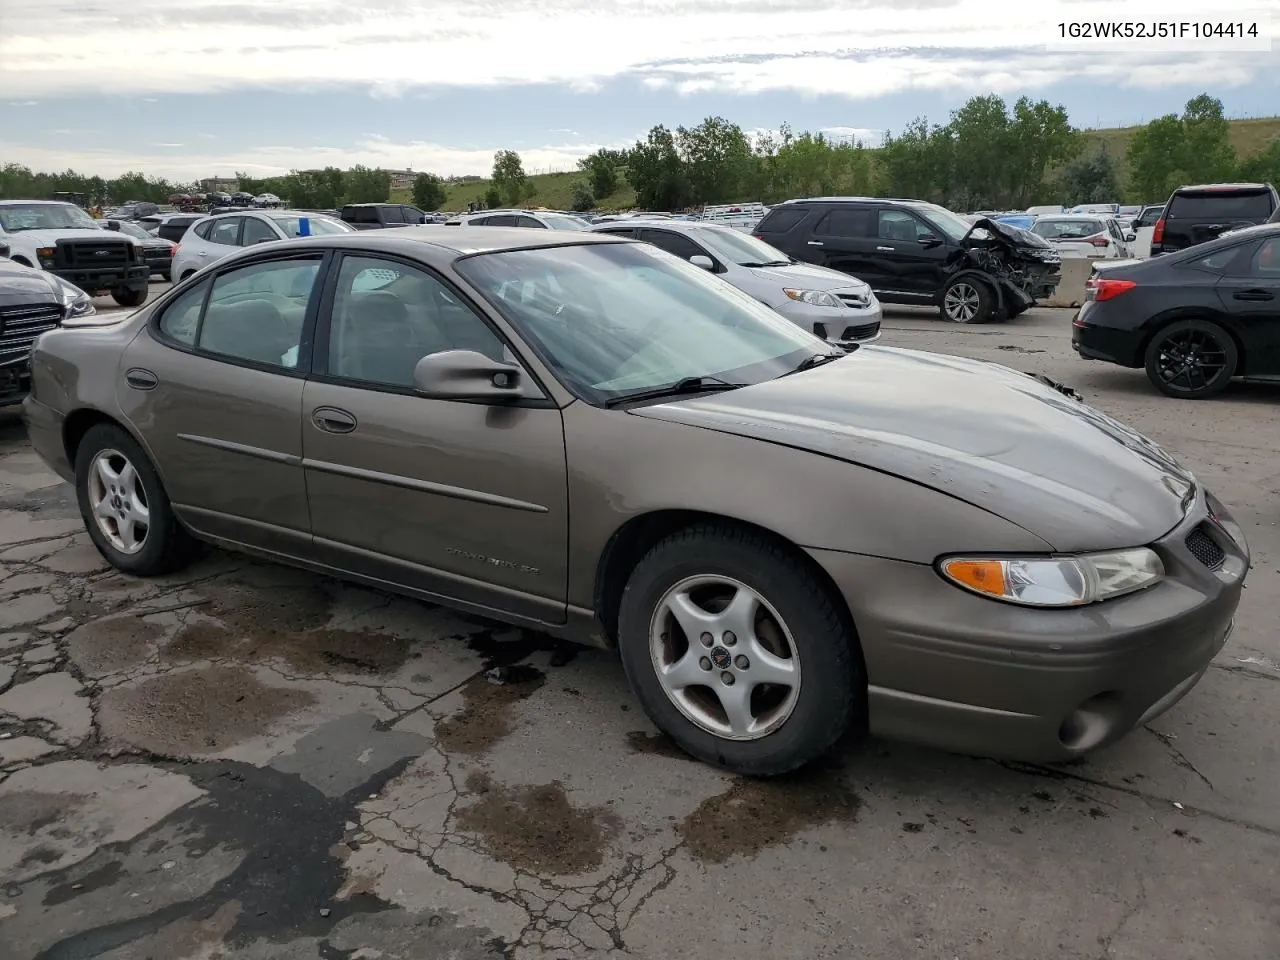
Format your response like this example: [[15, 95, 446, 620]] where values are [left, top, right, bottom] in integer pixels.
[[302, 253, 568, 623]]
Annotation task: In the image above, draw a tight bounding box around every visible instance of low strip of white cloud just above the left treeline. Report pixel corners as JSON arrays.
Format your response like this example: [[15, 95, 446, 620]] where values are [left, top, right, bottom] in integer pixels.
[[4, 138, 635, 183]]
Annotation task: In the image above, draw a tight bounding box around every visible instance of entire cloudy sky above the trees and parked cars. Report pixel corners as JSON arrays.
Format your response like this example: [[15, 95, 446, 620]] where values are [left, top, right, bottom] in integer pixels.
[[0, 0, 1280, 180]]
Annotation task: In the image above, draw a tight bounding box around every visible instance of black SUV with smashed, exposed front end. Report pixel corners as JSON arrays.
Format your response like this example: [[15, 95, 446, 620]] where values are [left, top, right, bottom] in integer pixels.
[[753, 197, 1062, 324]]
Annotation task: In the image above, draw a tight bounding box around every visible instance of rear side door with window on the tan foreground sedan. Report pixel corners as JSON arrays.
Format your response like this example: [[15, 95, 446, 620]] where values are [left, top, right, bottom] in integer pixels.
[[119, 251, 324, 553]]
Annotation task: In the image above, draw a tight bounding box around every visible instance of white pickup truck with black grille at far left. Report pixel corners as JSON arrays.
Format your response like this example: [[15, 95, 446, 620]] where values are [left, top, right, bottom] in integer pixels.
[[0, 200, 151, 307]]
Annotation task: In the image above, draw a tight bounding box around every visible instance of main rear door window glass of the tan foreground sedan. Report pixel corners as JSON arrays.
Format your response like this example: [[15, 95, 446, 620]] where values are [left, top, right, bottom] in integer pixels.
[[196, 257, 320, 370]]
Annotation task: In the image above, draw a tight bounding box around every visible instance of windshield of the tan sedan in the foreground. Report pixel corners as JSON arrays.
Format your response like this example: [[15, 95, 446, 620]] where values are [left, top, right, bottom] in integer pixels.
[[457, 243, 831, 403]]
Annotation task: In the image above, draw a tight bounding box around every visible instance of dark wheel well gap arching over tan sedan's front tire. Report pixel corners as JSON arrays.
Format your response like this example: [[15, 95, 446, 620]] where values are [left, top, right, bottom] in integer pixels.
[[595, 509, 865, 669]]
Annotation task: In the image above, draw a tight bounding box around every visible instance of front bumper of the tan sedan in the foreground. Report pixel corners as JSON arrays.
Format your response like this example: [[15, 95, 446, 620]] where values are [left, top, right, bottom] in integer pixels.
[[809, 494, 1249, 762]]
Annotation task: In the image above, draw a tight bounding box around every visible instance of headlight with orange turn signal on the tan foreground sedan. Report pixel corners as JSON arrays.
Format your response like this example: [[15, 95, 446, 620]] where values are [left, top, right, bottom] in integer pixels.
[[938, 547, 1165, 607]]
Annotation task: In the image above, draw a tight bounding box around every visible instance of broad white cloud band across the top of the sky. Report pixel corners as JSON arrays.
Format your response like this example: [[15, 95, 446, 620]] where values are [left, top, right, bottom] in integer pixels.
[[0, 0, 1277, 99]]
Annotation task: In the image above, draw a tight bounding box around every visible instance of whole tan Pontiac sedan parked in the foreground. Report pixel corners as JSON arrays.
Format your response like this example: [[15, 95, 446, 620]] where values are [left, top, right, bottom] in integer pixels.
[[24, 227, 1249, 774]]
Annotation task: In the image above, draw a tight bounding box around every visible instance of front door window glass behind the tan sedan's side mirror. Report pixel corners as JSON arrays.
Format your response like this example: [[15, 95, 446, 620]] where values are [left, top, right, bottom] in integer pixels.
[[326, 256, 512, 389]]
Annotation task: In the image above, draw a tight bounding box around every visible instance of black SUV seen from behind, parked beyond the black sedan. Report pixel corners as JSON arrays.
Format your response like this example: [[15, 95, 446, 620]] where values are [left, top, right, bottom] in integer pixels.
[[1151, 183, 1280, 256]]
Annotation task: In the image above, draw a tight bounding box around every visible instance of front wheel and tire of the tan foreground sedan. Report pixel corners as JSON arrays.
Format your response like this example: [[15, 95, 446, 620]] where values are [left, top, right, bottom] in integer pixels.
[[618, 526, 867, 777]]
